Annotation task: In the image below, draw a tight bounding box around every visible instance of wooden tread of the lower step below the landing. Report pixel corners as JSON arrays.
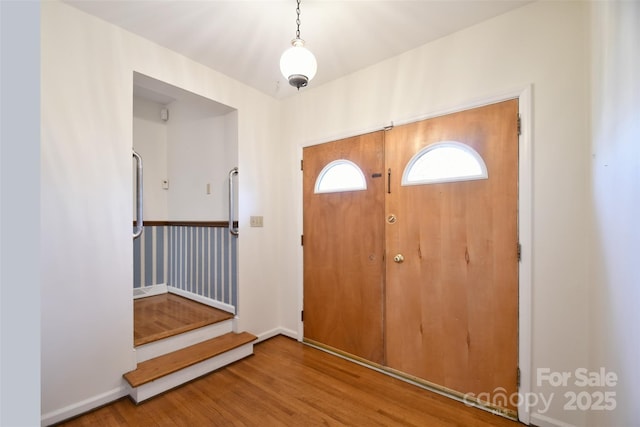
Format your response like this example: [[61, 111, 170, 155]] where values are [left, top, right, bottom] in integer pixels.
[[124, 332, 257, 388]]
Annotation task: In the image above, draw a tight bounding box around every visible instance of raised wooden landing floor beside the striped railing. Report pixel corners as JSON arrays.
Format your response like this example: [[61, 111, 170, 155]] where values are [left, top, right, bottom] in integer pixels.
[[133, 293, 233, 346]]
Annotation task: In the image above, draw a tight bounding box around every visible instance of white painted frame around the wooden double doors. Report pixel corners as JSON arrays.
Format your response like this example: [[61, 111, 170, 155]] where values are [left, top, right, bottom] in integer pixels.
[[297, 84, 533, 425]]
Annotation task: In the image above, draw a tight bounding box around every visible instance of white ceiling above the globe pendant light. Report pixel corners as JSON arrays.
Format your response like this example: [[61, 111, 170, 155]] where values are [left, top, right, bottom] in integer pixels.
[[66, 0, 532, 98]]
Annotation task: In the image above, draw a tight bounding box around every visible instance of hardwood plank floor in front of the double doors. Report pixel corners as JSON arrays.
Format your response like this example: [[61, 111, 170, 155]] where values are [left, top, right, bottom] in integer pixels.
[[61, 336, 520, 427]]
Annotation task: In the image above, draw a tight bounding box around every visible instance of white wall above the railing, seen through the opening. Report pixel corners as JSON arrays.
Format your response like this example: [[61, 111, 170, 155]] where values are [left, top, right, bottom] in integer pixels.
[[133, 96, 238, 221]]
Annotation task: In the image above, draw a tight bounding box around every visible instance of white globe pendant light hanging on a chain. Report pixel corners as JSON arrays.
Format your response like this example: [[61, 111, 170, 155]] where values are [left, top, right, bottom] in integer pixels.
[[280, 0, 318, 90]]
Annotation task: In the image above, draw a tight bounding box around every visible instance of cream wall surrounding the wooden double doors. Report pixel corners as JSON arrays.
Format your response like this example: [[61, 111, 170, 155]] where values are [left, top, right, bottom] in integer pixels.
[[281, 2, 590, 425]]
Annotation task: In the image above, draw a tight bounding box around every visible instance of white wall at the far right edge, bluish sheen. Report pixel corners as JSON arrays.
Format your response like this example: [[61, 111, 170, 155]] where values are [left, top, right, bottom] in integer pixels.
[[587, 2, 640, 426]]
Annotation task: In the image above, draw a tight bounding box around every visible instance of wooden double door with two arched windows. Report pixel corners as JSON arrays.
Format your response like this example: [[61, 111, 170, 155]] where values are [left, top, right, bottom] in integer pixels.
[[303, 100, 518, 414]]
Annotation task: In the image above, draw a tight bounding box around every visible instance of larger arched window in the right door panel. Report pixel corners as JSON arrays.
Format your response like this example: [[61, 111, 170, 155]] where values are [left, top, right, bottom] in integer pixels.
[[402, 141, 489, 185]]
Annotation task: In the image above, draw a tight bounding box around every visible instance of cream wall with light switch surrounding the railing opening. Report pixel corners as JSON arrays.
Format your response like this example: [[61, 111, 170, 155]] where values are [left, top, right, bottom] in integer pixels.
[[40, 2, 280, 423]]
